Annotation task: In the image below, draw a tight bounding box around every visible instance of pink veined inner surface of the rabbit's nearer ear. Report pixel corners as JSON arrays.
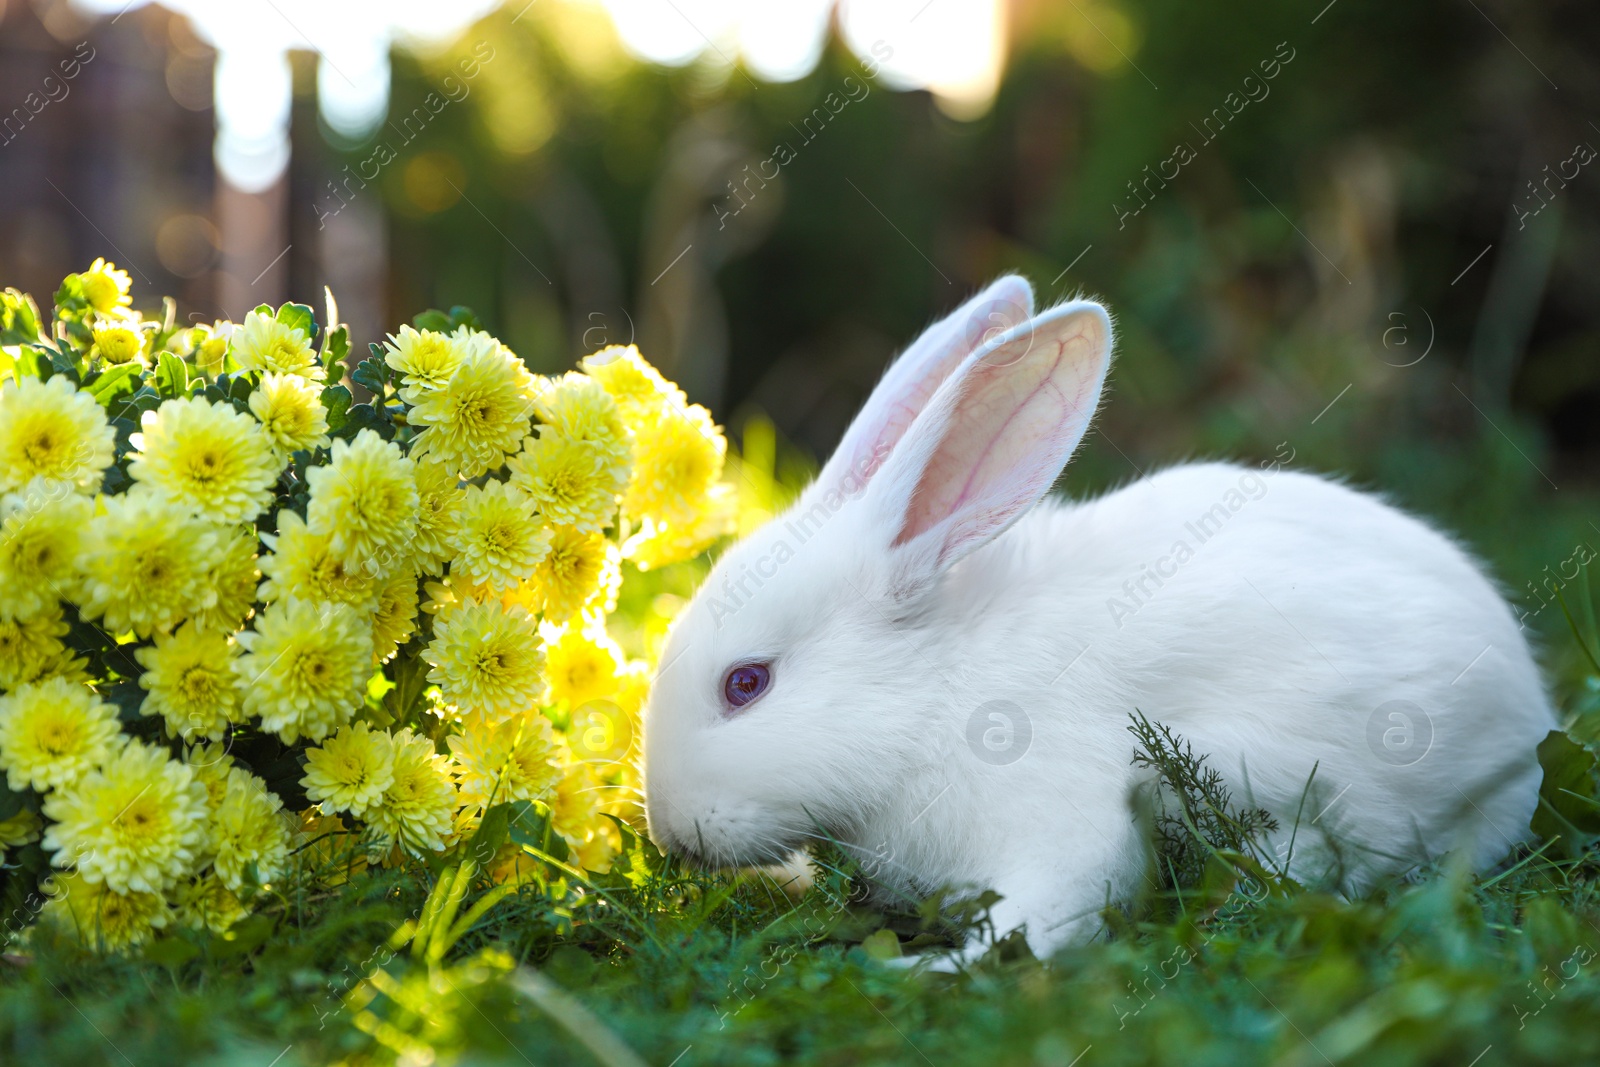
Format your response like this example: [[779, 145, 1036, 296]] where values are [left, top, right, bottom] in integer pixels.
[[894, 314, 1106, 558]]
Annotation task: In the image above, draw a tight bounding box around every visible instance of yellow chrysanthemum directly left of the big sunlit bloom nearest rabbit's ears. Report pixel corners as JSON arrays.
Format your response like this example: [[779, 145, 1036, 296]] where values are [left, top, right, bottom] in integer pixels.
[[509, 427, 632, 533]]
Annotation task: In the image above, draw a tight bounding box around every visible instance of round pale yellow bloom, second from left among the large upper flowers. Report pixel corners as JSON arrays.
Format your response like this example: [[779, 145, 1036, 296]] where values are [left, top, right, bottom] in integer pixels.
[[128, 397, 283, 523]]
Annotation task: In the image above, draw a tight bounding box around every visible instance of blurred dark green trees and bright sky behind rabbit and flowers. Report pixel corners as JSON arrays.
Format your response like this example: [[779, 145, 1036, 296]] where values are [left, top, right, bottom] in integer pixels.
[[0, 0, 1600, 671]]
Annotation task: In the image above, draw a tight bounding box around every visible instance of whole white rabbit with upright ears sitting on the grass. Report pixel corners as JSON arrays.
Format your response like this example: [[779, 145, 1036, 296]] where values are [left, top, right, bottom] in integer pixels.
[[645, 277, 1555, 955]]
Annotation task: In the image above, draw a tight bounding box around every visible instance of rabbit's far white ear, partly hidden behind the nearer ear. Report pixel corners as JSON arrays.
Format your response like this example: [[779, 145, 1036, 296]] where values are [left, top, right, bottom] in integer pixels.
[[814, 274, 1034, 496]]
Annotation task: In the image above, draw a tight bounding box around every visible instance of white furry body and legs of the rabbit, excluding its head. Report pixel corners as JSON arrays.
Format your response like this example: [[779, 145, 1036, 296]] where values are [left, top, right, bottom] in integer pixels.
[[850, 464, 1554, 950]]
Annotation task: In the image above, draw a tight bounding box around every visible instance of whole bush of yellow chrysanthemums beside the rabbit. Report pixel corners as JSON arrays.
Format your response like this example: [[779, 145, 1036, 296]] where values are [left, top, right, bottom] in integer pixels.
[[0, 261, 733, 950]]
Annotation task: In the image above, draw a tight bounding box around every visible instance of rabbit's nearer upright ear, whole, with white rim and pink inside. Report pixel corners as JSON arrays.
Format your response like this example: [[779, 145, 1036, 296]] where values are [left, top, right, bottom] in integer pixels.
[[870, 301, 1112, 587]]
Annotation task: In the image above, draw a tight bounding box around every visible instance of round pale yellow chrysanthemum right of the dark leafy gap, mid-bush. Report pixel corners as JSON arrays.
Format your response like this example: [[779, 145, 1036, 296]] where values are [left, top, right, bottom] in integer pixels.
[[422, 600, 544, 718]]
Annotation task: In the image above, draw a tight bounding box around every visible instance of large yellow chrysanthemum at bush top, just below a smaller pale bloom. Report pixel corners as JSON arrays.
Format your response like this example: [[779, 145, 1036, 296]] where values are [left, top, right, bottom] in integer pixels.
[[408, 349, 533, 478]]
